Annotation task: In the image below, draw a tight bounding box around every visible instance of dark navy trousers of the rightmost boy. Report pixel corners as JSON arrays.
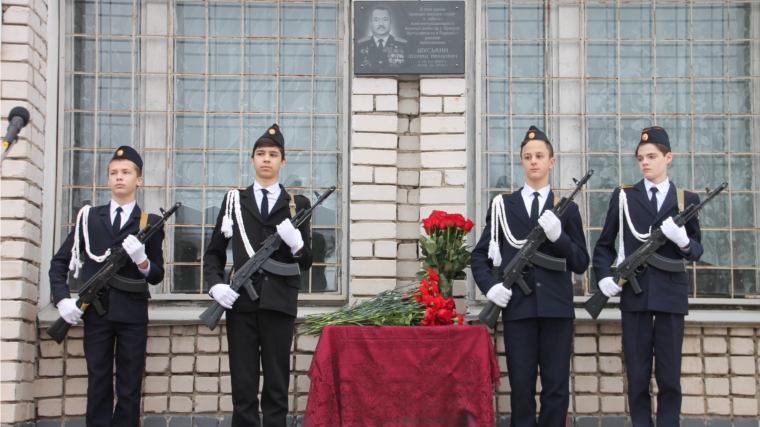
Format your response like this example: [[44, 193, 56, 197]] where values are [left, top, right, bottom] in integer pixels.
[[622, 311, 684, 427]]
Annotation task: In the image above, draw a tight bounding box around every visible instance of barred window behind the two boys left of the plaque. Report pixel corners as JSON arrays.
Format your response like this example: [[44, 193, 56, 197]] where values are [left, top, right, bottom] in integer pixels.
[[60, 0, 345, 295]]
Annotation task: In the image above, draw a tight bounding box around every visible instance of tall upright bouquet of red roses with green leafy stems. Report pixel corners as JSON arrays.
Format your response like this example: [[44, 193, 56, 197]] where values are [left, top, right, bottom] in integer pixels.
[[417, 211, 475, 297]]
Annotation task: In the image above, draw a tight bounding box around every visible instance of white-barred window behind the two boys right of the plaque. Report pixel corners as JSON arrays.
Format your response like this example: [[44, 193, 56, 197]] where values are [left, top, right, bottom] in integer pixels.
[[478, 1, 760, 298]]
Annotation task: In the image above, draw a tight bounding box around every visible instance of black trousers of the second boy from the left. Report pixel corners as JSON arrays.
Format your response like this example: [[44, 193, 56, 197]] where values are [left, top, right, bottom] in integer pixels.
[[227, 310, 295, 427]]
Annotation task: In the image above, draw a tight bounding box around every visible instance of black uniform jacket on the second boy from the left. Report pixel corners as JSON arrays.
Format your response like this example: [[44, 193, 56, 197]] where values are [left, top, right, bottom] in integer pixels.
[[203, 185, 313, 316]]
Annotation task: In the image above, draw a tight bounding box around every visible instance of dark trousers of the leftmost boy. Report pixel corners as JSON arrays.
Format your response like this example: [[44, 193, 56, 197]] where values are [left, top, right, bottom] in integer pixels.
[[83, 309, 148, 427]]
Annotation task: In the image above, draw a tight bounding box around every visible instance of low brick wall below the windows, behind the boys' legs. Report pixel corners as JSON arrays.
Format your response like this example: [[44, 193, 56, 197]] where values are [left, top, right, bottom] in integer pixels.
[[26, 321, 760, 427]]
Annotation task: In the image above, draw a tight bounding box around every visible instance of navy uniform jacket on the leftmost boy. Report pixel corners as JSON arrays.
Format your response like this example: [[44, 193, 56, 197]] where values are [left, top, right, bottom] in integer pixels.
[[49, 204, 164, 324]]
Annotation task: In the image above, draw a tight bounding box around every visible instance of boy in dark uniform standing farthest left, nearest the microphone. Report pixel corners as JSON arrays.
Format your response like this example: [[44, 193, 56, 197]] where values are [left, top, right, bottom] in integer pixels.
[[50, 146, 164, 427]]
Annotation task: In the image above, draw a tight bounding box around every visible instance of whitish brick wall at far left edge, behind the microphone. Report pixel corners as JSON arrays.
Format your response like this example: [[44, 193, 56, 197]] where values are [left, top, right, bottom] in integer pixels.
[[0, 0, 48, 424]]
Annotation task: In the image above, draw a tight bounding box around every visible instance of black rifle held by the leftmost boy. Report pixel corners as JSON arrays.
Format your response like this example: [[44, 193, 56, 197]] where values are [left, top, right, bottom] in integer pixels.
[[45, 202, 182, 344]]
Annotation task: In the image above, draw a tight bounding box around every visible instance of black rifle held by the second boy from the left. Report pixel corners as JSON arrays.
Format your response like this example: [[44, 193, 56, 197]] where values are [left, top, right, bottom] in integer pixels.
[[199, 186, 335, 331]]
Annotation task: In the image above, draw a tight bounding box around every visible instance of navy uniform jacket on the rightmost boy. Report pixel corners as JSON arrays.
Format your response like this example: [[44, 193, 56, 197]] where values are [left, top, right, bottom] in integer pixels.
[[593, 179, 703, 315]]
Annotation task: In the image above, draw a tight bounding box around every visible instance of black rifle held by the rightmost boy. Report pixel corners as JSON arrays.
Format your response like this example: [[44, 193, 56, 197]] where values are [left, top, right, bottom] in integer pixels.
[[583, 182, 728, 319]]
